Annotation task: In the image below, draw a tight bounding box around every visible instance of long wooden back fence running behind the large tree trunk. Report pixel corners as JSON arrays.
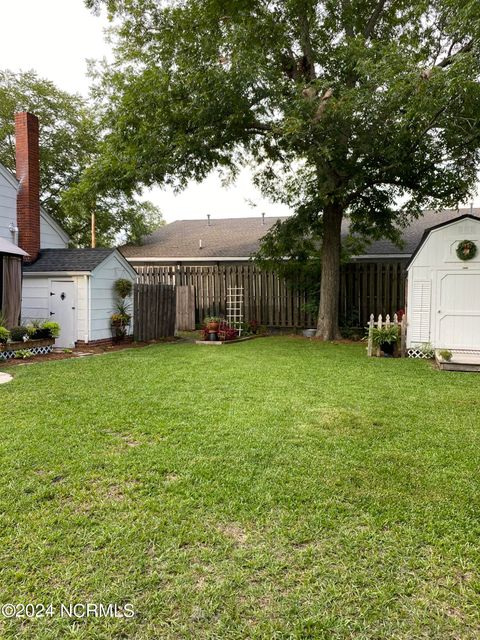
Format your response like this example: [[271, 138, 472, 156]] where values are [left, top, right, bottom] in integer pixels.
[[136, 260, 406, 328]]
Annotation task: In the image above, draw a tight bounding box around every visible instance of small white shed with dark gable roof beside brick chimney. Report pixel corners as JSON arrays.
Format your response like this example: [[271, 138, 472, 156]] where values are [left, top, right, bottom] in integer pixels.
[[22, 249, 137, 347]]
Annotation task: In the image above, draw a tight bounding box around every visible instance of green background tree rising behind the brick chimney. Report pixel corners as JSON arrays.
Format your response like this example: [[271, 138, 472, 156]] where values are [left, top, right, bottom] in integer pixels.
[[0, 70, 163, 246]]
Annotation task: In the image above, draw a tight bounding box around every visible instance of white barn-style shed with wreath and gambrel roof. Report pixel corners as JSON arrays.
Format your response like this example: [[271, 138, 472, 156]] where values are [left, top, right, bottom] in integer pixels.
[[407, 214, 480, 364]]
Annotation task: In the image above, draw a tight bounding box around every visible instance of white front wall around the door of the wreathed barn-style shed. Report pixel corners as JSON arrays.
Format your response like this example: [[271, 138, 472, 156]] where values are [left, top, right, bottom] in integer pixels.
[[407, 218, 480, 348]]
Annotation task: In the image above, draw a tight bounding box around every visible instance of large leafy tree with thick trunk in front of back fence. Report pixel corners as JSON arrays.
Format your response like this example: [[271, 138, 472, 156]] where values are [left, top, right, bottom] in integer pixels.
[[86, 0, 480, 339]]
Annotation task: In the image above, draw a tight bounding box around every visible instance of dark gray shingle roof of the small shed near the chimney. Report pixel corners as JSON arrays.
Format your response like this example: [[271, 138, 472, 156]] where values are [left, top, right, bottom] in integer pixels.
[[23, 249, 115, 273]]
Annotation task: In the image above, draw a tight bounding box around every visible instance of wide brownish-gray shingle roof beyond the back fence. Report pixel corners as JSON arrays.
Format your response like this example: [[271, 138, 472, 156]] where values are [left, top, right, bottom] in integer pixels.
[[120, 209, 480, 259]]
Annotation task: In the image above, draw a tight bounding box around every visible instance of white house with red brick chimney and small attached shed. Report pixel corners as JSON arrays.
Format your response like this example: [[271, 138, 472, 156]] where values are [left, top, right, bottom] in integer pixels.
[[0, 112, 136, 347]]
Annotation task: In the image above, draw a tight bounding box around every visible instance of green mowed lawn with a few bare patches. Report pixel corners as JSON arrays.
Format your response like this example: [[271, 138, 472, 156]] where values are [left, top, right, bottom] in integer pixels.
[[0, 338, 480, 640]]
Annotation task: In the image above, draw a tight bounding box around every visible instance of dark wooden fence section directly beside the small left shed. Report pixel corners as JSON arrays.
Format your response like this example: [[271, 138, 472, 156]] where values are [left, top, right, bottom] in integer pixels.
[[133, 283, 176, 342]]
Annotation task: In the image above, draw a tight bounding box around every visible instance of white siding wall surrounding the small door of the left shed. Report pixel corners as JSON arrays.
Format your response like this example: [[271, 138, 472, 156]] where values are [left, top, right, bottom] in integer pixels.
[[22, 274, 88, 341]]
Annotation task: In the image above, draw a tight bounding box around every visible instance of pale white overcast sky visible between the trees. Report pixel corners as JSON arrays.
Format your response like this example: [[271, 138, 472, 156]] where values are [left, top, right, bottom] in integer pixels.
[[0, 0, 480, 222]]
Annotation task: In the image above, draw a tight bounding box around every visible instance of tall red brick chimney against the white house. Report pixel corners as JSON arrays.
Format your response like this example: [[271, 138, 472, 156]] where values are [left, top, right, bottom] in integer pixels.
[[15, 111, 40, 262]]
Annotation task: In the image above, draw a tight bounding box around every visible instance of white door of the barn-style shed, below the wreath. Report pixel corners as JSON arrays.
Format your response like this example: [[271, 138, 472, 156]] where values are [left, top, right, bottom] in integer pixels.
[[432, 270, 480, 350]]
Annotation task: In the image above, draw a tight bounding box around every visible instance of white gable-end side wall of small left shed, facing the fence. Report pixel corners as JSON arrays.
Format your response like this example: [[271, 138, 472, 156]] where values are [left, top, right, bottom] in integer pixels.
[[90, 254, 135, 340]]
